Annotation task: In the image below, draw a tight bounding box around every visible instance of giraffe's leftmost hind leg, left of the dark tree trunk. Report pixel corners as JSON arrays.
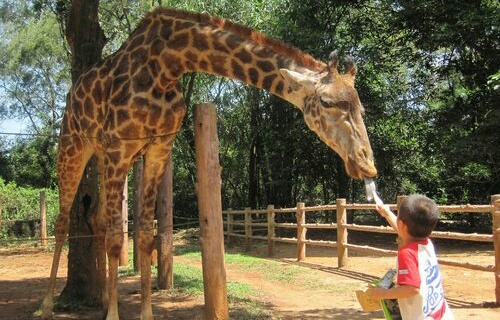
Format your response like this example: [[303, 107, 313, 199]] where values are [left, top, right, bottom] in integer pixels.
[[41, 136, 93, 319]]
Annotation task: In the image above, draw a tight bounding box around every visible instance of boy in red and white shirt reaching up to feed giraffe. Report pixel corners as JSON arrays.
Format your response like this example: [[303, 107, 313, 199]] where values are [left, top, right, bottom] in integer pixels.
[[369, 194, 454, 320]]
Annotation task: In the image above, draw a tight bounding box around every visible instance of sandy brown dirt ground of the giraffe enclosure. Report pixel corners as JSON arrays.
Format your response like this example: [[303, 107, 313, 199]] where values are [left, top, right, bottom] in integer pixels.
[[0, 234, 500, 320]]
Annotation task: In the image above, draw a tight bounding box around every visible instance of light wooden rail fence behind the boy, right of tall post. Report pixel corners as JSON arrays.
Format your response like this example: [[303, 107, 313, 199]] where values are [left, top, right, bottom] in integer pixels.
[[222, 195, 500, 305]]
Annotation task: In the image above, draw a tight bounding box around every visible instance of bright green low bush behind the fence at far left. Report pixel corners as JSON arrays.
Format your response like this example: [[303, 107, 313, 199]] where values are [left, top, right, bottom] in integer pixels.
[[0, 177, 59, 235]]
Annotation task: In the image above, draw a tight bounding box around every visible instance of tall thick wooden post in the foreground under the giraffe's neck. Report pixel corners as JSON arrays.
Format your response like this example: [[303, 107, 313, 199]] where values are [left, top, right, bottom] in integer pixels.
[[194, 104, 229, 320]]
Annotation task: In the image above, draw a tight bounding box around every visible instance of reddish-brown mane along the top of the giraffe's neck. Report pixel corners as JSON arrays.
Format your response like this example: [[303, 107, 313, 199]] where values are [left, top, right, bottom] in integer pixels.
[[144, 7, 326, 72]]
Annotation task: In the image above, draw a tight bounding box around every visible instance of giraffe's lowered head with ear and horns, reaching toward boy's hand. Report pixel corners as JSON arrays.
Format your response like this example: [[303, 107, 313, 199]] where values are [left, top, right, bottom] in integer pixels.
[[280, 52, 377, 179]]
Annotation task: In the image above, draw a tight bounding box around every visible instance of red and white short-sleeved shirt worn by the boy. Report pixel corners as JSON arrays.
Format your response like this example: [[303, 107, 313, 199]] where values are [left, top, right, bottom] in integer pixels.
[[397, 238, 454, 320]]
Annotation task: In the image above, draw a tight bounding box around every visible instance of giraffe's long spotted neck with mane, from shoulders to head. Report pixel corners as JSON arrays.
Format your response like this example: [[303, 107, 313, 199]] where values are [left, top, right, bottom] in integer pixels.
[[125, 9, 325, 103]]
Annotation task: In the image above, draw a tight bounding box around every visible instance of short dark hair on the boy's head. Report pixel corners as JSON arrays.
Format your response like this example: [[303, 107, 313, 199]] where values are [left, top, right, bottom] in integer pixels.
[[398, 194, 439, 238]]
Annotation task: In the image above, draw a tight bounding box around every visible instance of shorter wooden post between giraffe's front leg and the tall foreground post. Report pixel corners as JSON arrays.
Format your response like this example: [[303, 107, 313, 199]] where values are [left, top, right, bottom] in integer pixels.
[[157, 156, 174, 290]]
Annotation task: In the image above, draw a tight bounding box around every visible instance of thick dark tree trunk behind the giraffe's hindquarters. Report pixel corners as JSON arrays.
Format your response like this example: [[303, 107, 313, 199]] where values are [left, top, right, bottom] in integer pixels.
[[60, 0, 106, 304]]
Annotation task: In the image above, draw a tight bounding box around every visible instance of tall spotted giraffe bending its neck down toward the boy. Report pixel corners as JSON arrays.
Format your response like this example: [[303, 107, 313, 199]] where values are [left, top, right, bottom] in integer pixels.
[[42, 8, 377, 320]]
